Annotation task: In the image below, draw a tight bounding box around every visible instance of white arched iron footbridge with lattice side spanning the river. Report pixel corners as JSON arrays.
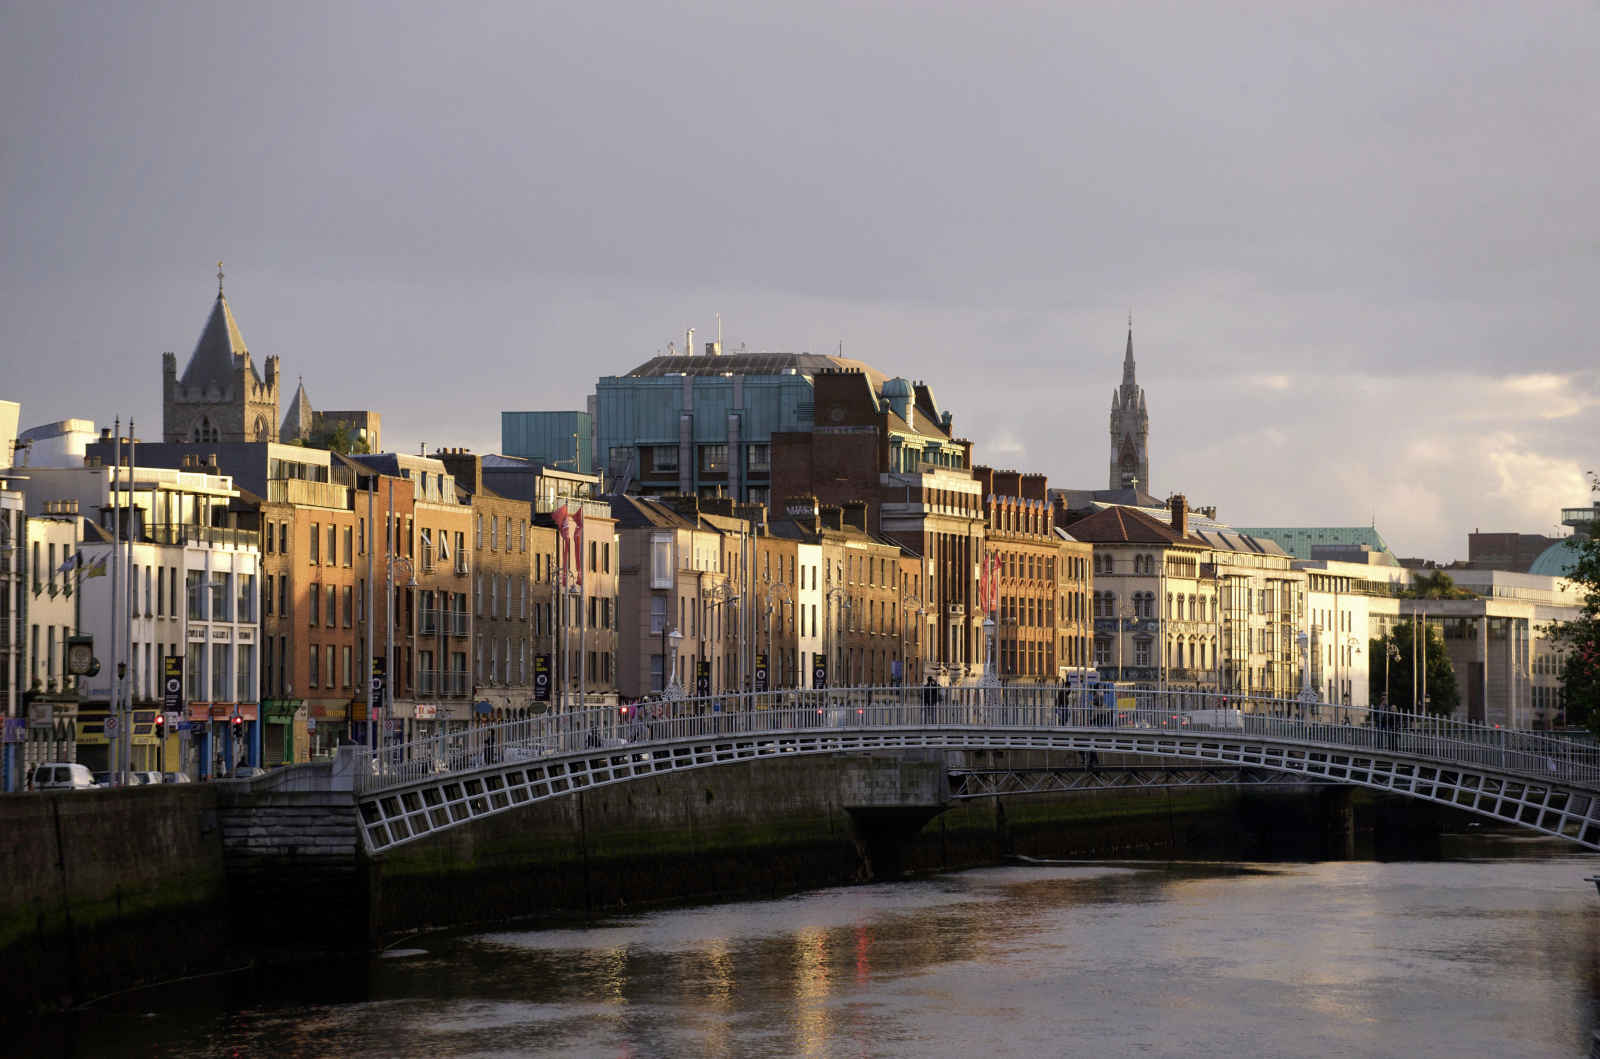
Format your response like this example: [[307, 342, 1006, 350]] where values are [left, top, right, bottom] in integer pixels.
[[355, 686, 1600, 854]]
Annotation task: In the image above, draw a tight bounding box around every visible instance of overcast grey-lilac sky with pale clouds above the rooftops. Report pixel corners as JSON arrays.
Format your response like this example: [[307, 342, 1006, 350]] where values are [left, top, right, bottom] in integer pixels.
[[0, 0, 1600, 560]]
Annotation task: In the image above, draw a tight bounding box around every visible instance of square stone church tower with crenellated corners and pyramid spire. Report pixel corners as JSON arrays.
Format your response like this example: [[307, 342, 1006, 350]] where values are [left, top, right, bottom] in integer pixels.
[[162, 270, 278, 442]]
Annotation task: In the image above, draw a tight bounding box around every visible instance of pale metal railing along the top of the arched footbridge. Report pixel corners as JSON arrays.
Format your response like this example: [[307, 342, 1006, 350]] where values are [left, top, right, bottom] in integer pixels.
[[358, 685, 1600, 790]]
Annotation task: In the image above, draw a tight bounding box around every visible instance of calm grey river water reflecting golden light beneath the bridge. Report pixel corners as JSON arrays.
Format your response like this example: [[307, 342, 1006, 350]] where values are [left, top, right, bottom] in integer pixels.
[[30, 835, 1600, 1059]]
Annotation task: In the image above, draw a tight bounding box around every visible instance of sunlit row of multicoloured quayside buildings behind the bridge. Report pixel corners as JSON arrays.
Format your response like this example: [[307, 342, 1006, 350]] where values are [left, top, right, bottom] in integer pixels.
[[0, 286, 1592, 789]]
